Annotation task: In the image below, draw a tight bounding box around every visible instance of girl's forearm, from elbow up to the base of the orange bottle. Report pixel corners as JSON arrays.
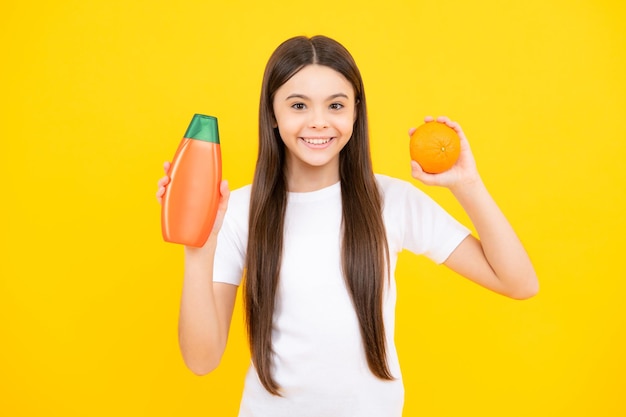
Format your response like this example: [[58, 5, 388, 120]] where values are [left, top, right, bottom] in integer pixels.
[[178, 244, 228, 374]]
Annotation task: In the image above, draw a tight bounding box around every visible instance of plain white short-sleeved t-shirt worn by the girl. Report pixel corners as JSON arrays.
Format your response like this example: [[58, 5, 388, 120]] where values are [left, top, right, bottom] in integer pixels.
[[214, 175, 469, 417]]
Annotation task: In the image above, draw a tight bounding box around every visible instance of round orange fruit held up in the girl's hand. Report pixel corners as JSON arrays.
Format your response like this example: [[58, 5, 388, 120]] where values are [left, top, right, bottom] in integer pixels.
[[409, 122, 461, 174]]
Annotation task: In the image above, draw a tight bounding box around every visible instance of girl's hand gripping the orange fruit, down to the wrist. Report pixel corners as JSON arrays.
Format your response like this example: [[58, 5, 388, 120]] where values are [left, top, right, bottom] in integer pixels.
[[409, 116, 480, 188]]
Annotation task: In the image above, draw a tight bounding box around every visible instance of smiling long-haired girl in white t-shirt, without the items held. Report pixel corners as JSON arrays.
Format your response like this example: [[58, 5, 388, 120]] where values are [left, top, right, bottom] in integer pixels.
[[157, 36, 538, 417]]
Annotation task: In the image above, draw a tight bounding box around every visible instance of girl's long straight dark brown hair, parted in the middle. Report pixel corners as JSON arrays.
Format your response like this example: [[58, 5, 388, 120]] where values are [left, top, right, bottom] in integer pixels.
[[244, 36, 393, 395]]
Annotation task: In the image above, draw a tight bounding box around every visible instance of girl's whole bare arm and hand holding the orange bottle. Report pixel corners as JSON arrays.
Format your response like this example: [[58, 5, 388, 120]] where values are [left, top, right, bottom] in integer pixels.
[[157, 163, 237, 375]]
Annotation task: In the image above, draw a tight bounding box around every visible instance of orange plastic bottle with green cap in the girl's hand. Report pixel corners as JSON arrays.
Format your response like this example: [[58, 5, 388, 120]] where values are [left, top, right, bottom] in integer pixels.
[[161, 114, 222, 247]]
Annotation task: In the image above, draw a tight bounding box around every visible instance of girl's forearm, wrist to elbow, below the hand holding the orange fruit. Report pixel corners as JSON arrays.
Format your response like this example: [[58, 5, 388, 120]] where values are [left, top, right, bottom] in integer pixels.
[[451, 179, 538, 298]]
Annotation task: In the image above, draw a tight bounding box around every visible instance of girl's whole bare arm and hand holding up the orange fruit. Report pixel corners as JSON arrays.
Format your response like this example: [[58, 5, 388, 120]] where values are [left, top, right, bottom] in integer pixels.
[[411, 117, 539, 299]]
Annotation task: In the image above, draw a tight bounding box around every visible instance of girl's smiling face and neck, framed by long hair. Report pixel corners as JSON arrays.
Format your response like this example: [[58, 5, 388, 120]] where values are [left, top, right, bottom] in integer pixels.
[[273, 65, 356, 191]]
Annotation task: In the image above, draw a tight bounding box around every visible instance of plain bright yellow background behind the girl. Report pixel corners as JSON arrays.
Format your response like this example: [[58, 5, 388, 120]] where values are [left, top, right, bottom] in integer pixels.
[[0, 0, 626, 416]]
